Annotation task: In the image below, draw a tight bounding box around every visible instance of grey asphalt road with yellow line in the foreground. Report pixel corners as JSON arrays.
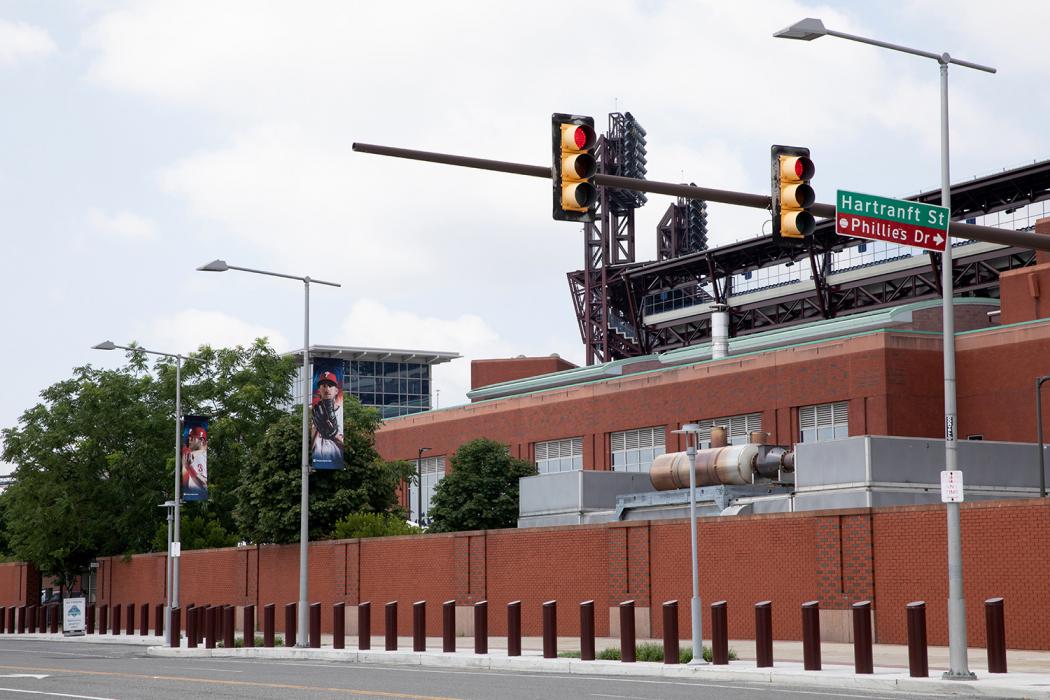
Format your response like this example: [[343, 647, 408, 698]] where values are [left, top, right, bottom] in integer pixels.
[[0, 639, 991, 700]]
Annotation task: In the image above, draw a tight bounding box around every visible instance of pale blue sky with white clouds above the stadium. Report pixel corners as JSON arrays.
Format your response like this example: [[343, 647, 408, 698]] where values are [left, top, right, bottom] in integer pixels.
[[0, 0, 1050, 471]]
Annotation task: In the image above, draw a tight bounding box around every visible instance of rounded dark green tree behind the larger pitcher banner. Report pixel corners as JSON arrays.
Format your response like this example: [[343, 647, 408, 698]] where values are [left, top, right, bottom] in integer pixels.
[[233, 395, 413, 544]]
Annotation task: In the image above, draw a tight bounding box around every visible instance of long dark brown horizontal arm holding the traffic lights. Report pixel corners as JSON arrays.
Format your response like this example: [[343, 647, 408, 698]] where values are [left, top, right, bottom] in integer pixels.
[[353, 144, 1050, 252]]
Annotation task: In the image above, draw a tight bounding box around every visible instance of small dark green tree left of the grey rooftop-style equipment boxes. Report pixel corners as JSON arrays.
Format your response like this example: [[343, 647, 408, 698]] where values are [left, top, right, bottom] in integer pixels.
[[429, 438, 537, 532]]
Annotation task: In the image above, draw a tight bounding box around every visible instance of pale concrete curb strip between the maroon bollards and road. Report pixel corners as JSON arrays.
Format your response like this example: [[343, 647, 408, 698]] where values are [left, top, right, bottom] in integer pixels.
[[146, 646, 1050, 700]]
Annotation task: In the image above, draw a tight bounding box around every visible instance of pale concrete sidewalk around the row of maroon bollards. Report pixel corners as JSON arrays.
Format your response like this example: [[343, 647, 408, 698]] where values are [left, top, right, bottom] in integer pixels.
[[10, 634, 1050, 700]]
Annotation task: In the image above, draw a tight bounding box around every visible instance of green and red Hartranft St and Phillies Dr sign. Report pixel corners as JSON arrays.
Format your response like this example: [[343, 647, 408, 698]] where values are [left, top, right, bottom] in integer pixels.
[[835, 190, 948, 253]]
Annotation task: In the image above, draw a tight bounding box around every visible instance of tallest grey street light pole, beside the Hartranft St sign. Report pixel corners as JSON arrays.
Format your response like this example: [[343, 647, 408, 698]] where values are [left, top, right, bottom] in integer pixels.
[[773, 18, 995, 680]]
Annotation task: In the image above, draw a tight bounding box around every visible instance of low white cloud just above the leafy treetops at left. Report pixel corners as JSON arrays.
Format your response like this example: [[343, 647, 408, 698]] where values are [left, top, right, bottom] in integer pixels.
[[135, 309, 291, 354]]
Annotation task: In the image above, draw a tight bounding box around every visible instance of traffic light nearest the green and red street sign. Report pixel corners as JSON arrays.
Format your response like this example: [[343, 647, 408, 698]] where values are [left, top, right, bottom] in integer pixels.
[[770, 146, 817, 243]]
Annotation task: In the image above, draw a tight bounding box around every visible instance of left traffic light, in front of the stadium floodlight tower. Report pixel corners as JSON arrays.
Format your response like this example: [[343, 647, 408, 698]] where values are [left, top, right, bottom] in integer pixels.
[[550, 113, 597, 221]]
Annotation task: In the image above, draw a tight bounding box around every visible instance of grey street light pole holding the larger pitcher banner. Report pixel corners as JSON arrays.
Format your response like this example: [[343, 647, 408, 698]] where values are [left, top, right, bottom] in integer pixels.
[[197, 260, 341, 646]]
